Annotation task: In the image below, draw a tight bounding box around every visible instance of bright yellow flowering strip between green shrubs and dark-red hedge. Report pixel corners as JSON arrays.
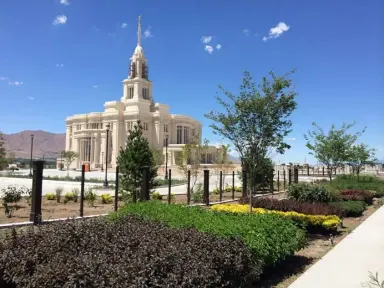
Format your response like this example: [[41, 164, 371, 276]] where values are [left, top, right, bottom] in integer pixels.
[[211, 204, 341, 231]]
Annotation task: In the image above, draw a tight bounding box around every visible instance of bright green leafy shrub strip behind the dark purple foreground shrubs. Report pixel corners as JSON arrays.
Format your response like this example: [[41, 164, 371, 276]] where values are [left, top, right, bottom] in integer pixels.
[[110, 201, 306, 265]]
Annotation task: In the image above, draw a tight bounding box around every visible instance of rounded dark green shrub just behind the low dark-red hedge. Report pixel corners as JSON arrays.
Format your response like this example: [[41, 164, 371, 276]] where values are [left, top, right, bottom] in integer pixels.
[[287, 182, 332, 203]]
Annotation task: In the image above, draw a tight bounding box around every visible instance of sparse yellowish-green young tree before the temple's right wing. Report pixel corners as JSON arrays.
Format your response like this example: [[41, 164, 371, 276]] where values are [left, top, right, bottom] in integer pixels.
[[177, 137, 209, 190]]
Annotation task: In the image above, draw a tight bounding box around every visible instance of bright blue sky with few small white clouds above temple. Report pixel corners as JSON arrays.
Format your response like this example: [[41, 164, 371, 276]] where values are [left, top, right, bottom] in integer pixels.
[[0, 0, 384, 162]]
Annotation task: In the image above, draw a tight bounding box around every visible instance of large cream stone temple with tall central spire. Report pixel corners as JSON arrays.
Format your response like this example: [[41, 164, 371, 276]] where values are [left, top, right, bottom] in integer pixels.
[[65, 17, 215, 169]]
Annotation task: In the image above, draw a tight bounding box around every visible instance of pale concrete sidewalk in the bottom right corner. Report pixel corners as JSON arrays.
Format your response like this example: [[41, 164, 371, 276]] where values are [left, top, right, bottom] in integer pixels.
[[289, 206, 384, 288]]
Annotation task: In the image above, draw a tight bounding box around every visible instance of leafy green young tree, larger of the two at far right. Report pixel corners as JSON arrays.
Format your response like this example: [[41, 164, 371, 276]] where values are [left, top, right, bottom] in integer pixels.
[[304, 123, 365, 181]]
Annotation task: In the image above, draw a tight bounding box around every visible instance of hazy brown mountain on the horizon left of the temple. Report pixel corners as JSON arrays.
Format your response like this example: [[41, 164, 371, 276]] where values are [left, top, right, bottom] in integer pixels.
[[3, 130, 65, 158]]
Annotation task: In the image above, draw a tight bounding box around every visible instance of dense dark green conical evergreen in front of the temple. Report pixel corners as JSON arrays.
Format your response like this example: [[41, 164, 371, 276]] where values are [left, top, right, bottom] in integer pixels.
[[117, 121, 157, 202]]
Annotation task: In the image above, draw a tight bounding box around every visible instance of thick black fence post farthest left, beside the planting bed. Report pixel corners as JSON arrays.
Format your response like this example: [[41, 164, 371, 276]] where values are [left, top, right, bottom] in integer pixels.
[[29, 160, 44, 225]]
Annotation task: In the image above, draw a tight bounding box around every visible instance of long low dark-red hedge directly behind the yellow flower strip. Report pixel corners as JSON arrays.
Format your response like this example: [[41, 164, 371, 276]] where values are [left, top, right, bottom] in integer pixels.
[[239, 197, 343, 216]]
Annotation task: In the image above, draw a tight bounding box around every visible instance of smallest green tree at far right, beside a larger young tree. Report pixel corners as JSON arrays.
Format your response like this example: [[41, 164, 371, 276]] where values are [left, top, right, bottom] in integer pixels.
[[347, 144, 377, 175]]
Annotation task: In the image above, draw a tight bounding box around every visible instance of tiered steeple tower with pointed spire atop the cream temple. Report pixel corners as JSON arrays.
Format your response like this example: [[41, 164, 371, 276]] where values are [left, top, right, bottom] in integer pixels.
[[122, 16, 153, 103]]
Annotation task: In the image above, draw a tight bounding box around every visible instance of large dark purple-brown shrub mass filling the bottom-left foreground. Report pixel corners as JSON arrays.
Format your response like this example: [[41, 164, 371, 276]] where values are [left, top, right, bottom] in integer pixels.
[[0, 216, 261, 288]]
